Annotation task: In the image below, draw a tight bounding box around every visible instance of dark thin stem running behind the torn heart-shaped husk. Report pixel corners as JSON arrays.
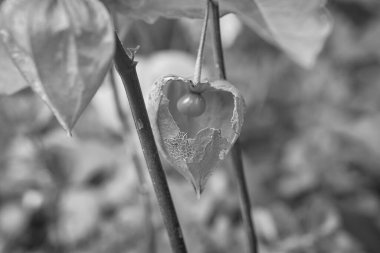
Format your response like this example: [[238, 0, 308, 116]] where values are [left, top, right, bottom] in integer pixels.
[[208, 0, 258, 253]]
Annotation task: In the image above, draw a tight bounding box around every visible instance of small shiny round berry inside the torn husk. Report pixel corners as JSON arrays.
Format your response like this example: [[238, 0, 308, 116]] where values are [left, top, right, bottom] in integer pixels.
[[177, 92, 206, 117]]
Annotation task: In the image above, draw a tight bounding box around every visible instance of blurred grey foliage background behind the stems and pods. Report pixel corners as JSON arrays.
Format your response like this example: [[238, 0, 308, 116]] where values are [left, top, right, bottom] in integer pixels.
[[0, 0, 380, 253]]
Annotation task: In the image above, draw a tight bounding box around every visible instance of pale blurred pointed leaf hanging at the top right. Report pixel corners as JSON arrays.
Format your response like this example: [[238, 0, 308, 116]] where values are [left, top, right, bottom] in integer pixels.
[[236, 0, 331, 68]]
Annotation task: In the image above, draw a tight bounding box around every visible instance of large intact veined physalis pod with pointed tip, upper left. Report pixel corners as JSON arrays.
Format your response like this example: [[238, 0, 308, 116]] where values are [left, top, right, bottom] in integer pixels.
[[2, 0, 114, 133]]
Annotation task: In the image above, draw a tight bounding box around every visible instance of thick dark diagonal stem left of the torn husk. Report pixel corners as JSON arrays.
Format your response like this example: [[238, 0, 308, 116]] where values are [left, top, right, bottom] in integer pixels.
[[114, 32, 187, 253]]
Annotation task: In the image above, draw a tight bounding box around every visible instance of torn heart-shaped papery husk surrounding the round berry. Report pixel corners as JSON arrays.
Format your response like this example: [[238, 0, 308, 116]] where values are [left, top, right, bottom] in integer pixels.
[[148, 76, 245, 195]]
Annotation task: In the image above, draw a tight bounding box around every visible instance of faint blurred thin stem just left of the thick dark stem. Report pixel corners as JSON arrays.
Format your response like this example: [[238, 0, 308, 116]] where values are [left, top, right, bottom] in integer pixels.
[[109, 66, 156, 253]]
